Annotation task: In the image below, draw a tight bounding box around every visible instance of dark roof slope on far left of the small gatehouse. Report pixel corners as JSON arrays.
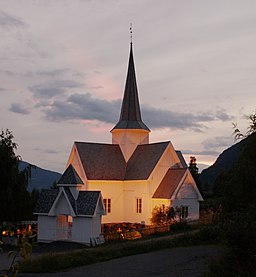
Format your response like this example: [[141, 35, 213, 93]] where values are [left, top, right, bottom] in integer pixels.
[[34, 189, 59, 214]]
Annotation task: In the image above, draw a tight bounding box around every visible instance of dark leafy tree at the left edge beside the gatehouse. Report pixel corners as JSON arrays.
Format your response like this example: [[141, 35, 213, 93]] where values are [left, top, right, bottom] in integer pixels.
[[0, 129, 35, 222]]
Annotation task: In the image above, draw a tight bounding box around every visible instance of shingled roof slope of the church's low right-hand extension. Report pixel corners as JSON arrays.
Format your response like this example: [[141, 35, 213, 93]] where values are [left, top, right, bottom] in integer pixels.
[[153, 168, 187, 199]]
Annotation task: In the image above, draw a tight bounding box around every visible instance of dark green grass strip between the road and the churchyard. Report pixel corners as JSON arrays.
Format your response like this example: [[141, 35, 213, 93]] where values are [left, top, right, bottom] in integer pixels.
[[21, 226, 220, 272]]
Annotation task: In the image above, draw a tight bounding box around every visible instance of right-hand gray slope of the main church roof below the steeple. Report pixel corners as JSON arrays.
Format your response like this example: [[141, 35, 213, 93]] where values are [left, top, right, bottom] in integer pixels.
[[125, 142, 170, 180]]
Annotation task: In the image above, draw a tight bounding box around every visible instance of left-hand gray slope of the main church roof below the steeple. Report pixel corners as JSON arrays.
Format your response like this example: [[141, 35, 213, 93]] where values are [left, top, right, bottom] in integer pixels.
[[75, 142, 126, 180]]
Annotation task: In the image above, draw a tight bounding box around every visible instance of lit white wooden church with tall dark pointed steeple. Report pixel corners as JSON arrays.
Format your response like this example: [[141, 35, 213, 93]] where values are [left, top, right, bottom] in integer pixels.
[[63, 43, 202, 224]]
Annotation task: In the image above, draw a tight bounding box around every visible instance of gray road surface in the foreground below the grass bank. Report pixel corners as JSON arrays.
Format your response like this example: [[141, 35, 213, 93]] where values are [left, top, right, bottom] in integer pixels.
[[18, 245, 221, 277]]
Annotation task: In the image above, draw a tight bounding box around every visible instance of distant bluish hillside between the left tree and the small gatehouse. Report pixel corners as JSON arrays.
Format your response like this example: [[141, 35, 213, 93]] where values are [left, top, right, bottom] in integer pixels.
[[19, 161, 61, 191]]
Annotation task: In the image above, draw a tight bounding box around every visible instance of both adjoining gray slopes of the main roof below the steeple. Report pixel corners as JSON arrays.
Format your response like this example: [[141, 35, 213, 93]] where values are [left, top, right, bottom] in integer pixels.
[[75, 142, 169, 181]]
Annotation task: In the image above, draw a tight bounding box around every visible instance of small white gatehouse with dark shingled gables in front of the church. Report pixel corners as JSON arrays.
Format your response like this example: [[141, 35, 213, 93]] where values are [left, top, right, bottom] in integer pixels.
[[35, 165, 105, 245]]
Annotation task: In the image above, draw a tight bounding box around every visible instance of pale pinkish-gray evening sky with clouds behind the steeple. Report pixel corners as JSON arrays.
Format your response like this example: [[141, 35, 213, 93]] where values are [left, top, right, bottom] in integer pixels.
[[0, 0, 256, 173]]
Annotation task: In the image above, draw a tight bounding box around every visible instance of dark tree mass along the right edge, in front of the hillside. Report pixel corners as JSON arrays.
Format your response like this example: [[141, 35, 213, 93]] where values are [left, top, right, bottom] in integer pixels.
[[214, 133, 256, 276]]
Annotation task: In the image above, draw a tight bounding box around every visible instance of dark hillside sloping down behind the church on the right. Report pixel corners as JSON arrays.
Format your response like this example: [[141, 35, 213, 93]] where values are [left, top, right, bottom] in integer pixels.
[[199, 134, 256, 192]]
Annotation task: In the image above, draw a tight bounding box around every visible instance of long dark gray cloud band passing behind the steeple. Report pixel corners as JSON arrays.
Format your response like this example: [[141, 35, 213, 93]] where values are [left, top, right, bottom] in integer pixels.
[[42, 93, 232, 132]]
